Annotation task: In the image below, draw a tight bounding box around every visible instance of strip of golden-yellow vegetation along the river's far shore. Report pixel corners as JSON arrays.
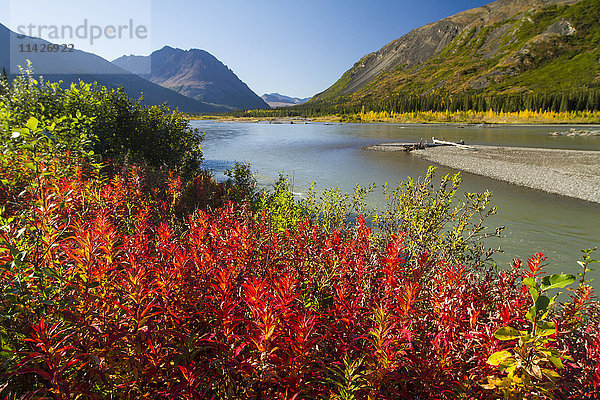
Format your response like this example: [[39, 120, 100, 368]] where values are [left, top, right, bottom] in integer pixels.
[[186, 110, 600, 125]]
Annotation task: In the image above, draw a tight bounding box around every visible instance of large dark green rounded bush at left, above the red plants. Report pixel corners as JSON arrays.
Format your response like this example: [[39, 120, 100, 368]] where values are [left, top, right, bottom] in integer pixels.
[[0, 65, 202, 176]]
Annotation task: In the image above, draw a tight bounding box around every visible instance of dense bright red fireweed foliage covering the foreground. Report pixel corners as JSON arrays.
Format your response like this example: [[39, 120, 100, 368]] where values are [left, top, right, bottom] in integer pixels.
[[0, 152, 600, 399]]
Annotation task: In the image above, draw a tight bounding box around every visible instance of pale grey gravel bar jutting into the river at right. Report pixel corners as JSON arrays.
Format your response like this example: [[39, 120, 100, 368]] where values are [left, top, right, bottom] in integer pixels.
[[412, 146, 600, 203]]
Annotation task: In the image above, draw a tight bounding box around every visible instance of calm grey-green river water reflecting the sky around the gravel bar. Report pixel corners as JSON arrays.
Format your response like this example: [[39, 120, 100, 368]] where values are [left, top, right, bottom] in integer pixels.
[[192, 121, 600, 287]]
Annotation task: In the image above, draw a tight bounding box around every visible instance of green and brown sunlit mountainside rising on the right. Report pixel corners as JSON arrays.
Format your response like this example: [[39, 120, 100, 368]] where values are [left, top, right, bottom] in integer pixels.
[[311, 0, 600, 105]]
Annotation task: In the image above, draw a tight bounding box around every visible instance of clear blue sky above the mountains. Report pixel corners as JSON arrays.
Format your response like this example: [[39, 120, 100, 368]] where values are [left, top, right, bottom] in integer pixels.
[[0, 0, 489, 97]]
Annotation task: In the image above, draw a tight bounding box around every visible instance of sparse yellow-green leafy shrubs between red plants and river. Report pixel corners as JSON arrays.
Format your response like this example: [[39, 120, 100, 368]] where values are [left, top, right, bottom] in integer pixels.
[[258, 167, 504, 277]]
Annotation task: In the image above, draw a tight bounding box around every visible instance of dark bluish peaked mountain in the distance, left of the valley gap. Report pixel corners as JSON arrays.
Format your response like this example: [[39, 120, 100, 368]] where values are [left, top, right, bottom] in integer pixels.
[[113, 46, 269, 110]]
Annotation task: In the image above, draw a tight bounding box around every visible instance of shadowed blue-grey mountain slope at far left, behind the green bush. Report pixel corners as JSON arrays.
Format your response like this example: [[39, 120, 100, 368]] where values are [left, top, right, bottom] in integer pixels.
[[0, 24, 225, 113]]
